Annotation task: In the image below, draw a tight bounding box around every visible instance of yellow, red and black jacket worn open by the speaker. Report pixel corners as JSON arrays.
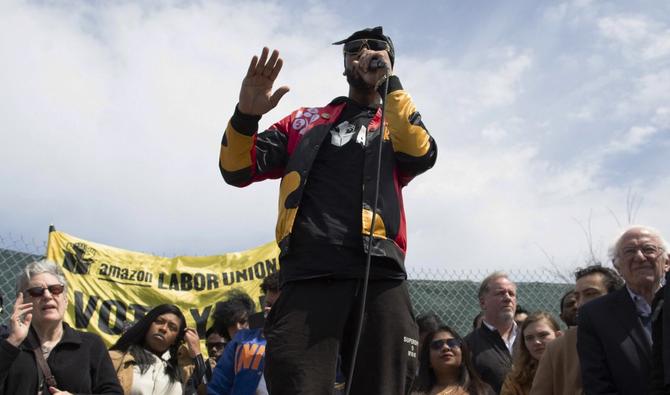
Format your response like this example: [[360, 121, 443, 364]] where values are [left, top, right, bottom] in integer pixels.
[[219, 76, 437, 267]]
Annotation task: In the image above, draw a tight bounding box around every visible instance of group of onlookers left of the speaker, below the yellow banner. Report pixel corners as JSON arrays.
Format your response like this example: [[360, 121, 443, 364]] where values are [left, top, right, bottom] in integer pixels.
[[0, 260, 280, 395]]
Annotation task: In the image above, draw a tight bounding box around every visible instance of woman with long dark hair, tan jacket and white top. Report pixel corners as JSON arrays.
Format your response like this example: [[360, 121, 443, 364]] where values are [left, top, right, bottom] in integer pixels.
[[109, 304, 211, 395]]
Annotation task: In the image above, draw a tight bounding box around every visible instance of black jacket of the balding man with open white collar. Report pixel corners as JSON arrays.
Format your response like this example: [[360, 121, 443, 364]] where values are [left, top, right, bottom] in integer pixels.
[[465, 324, 512, 394]]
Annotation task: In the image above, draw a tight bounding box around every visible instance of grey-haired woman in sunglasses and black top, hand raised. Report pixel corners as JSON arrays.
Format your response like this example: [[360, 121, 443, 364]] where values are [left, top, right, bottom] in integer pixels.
[[0, 261, 122, 395]]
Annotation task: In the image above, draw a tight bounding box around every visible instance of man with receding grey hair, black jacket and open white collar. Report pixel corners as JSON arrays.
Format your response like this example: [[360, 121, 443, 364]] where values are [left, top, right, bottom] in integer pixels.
[[465, 272, 518, 393]]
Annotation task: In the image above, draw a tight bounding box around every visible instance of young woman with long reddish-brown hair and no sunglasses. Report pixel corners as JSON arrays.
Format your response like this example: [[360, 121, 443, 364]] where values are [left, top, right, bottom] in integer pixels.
[[500, 311, 561, 395]]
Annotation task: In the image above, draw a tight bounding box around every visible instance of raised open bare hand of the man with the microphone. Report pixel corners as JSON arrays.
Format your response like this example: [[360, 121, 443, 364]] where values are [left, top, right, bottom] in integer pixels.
[[237, 47, 289, 115]]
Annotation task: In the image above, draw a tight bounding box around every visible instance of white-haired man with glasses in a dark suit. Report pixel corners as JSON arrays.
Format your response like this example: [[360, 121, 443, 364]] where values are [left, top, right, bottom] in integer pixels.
[[577, 226, 668, 395]]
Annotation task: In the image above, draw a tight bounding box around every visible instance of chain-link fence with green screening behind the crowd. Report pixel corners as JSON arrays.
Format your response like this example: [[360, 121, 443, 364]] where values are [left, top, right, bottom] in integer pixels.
[[0, 235, 572, 335]]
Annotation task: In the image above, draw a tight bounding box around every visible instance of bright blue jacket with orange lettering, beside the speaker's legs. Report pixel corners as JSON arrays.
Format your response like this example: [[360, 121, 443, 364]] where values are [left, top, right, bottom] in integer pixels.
[[207, 328, 266, 395]]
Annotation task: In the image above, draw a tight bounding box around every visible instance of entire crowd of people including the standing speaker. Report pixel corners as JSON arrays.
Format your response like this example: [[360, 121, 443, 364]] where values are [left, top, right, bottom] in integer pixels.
[[0, 26, 670, 395]]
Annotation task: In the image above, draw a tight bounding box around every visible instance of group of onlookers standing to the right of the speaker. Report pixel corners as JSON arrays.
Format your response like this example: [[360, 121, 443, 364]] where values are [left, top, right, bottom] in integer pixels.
[[415, 226, 670, 395]]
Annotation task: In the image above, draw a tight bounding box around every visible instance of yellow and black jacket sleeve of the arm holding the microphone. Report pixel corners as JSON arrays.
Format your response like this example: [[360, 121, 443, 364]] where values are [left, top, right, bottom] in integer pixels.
[[385, 75, 437, 185]]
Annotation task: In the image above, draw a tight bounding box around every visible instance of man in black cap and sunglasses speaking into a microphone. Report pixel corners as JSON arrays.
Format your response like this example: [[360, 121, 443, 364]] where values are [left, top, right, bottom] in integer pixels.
[[219, 27, 437, 395]]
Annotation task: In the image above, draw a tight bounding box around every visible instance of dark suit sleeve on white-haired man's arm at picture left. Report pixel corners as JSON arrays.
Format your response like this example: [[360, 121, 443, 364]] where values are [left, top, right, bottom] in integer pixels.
[[577, 304, 617, 395]]
